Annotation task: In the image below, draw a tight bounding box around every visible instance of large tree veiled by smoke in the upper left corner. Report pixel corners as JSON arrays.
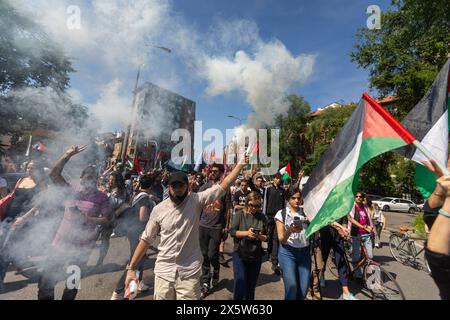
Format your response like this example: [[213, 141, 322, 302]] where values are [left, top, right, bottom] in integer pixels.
[[0, 0, 89, 146]]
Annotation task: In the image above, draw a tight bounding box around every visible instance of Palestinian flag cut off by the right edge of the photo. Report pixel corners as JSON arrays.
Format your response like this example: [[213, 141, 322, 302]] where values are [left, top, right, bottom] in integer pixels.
[[398, 59, 450, 199]]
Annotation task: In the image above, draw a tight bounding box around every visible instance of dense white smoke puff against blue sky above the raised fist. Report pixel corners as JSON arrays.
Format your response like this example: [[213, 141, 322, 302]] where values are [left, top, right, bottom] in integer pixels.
[[203, 40, 315, 128]]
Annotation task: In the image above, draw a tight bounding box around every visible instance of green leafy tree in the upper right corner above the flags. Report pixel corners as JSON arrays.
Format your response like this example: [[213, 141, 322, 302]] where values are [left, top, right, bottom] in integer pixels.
[[351, 0, 450, 119]]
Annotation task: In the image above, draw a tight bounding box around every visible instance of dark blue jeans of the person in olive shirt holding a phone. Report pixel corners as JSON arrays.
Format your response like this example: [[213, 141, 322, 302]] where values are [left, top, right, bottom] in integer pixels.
[[233, 252, 261, 300]]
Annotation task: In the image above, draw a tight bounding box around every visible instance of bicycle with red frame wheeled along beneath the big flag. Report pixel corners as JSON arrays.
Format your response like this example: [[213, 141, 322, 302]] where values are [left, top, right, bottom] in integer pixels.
[[327, 237, 405, 300]]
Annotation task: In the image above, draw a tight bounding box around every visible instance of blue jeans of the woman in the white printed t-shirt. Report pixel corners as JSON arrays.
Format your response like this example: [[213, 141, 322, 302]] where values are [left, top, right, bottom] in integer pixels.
[[278, 243, 311, 300]]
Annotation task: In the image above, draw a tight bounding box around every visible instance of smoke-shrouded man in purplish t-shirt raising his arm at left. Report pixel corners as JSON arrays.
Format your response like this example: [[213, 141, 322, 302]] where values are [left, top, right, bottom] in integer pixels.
[[38, 146, 111, 300]]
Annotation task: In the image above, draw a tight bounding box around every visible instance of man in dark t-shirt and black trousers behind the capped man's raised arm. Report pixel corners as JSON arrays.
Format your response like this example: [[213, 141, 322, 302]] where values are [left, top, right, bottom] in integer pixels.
[[199, 163, 231, 296]]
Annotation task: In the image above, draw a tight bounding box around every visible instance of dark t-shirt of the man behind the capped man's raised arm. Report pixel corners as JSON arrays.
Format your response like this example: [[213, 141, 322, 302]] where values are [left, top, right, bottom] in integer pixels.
[[198, 181, 231, 229]]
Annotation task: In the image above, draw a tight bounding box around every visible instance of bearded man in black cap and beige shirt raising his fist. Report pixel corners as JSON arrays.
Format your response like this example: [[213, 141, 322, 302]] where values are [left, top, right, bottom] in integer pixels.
[[125, 156, 248, 300]]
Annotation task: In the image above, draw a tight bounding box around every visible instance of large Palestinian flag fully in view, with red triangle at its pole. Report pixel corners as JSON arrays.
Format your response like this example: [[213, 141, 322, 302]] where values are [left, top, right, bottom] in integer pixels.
[[303, 93, 415, 236]]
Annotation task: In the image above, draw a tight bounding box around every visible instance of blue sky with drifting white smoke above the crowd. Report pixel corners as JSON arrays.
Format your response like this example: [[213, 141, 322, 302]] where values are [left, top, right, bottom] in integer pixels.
[[13, 0, 390, 144]]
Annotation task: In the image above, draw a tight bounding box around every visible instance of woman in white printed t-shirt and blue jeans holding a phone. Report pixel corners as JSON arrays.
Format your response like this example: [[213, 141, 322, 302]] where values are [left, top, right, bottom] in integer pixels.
[[275, 187, 311, 300]]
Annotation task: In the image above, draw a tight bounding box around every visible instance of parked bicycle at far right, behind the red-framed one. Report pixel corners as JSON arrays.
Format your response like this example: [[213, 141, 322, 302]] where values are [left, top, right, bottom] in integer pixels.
[[389, 226, 431, 273]]
